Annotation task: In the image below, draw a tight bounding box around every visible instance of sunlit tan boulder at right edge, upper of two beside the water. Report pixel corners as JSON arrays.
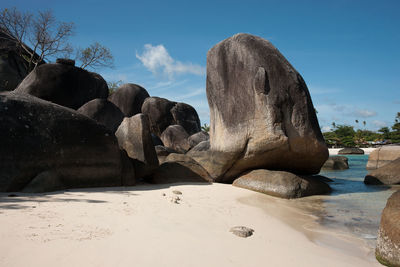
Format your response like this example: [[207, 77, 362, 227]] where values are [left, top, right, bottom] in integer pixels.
[[367, 145, 400, 170]]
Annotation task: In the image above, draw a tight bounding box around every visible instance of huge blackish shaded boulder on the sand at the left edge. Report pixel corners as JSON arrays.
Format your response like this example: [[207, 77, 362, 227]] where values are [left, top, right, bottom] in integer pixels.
[[0, 92, 135, 192]]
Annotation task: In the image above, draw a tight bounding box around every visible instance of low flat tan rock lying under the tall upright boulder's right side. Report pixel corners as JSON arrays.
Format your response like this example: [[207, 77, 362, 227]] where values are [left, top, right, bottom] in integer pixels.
[[233, 169, 331, 198]]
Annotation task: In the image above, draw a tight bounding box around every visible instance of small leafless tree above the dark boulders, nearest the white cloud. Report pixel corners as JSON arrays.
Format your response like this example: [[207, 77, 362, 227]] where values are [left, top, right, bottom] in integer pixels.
[[76, 42, 114, 69]]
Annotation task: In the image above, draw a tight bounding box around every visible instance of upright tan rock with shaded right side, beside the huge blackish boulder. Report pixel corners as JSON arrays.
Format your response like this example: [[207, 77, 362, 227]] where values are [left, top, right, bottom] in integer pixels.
[[115, 113, 158, 179]]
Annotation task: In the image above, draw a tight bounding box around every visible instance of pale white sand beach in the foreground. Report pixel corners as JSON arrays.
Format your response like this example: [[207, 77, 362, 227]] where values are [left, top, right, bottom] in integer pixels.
[[0, 184, 380, 267]]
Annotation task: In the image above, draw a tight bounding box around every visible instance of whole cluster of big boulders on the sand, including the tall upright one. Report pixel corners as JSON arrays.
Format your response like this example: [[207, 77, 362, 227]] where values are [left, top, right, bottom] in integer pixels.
[[0, 34, 330, 198]]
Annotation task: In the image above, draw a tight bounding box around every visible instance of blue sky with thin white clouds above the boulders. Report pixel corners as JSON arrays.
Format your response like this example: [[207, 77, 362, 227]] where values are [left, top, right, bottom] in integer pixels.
[[1, 0, 400, 131]]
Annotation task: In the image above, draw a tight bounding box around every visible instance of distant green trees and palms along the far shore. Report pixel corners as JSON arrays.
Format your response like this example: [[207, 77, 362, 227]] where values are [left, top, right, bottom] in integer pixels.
[[323, 112, 400, 147]]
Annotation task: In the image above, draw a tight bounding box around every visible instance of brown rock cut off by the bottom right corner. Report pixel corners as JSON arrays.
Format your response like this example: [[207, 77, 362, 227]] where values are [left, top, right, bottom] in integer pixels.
[[375, 190, 400, 266]]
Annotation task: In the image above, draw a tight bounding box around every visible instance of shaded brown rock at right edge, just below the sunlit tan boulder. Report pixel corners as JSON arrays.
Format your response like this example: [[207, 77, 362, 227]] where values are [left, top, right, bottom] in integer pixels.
[[364, 158, 400, 185]]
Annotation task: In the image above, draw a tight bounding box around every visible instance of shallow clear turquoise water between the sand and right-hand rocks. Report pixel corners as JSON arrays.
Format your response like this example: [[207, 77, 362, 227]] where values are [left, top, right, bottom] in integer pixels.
[[299, 155, 400, 247]]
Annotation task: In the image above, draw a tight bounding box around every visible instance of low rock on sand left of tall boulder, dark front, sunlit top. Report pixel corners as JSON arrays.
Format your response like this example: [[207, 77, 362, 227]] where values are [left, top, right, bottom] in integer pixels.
[[149, 153, 212, 184]]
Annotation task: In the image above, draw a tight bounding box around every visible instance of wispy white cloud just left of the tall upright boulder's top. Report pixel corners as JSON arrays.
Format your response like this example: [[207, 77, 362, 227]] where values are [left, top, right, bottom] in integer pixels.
[[136, 44, 205, 79]]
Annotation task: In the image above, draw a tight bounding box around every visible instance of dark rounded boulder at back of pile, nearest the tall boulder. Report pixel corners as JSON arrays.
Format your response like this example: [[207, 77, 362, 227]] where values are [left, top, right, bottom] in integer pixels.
[[171, 103, 201, 135]]
